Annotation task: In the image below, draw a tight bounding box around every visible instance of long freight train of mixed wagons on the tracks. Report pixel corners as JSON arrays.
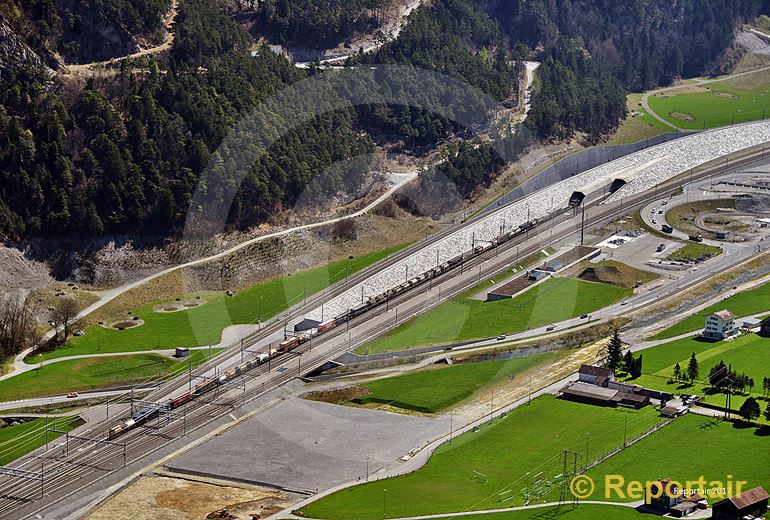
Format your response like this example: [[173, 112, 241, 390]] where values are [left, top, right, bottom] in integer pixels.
[[107, 220, 538, 439]]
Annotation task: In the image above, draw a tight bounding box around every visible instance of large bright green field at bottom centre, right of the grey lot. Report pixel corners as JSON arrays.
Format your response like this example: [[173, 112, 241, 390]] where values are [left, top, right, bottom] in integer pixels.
[[302, 396, 659, 520]]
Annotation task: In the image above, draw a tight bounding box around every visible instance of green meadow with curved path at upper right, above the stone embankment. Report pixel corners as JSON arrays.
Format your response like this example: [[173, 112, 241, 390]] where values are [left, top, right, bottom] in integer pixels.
[[647, 83, 770, 130]]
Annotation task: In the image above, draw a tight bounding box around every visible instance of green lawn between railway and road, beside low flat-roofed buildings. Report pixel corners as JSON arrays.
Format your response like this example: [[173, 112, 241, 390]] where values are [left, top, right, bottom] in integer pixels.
[[357, 277, 632, 354]]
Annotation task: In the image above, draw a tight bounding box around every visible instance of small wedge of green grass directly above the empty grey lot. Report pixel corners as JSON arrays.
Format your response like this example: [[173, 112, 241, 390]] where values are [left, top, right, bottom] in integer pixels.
[[354, 352, 557, 413]]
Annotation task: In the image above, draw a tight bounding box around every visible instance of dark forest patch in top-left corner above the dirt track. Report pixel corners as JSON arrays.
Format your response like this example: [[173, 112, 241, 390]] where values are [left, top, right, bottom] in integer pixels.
[[0, 0, 171, 63]]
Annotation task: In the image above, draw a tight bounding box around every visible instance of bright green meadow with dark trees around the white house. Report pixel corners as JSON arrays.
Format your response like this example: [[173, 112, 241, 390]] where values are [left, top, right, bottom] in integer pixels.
[[633, 334, 770, 418]]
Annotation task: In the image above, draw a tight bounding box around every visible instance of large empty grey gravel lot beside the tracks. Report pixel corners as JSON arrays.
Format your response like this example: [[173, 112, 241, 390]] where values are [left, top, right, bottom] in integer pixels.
[[167, 397, 450, 492]]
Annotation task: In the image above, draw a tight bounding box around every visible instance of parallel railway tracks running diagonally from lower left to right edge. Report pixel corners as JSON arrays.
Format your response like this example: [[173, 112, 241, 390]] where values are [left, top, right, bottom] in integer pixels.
[[0, 144, 761, 517]]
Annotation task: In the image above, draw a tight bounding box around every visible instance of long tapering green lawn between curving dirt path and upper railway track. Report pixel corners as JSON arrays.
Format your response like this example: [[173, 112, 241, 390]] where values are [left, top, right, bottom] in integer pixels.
[[28, 244, 407, 363]]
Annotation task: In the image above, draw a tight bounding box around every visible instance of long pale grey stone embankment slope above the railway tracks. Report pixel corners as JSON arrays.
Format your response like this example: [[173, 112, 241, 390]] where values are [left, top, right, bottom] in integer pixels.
[[307, 122, 770, 321]]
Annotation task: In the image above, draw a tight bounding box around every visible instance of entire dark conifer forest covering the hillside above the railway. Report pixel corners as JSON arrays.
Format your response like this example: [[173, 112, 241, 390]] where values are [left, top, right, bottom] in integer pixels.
[[0, 0, 766, 239]]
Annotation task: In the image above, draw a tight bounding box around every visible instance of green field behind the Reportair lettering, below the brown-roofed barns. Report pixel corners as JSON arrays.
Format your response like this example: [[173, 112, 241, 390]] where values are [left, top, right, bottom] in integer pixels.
[[588, 414, 770, 502]]
